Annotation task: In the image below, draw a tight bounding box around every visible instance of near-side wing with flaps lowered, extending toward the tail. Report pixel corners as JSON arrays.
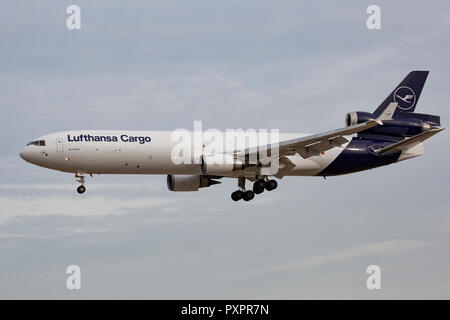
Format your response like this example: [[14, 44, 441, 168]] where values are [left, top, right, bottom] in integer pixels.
[[237, 119, 380, 158]]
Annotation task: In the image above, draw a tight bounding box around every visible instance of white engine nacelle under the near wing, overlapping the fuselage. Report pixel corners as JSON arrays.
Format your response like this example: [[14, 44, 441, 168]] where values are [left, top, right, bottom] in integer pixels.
[[201, 154, 244, 176]]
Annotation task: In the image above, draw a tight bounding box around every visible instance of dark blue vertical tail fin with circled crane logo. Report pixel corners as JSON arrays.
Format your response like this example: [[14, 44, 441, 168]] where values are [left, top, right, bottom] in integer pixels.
[[374, 71, 429, 117]]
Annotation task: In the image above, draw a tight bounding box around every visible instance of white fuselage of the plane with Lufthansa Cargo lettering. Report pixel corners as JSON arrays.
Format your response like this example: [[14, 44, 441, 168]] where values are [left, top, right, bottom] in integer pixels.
[[20, 130, 347, 177]]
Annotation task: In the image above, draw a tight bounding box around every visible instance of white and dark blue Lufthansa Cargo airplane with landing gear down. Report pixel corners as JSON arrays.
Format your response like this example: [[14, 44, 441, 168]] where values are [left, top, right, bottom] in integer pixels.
[[20, 71, 444, 201]]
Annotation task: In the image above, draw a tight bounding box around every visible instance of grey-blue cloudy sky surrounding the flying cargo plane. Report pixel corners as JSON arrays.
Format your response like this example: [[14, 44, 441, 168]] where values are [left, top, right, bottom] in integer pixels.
[[0, 0, 450, 299]]
